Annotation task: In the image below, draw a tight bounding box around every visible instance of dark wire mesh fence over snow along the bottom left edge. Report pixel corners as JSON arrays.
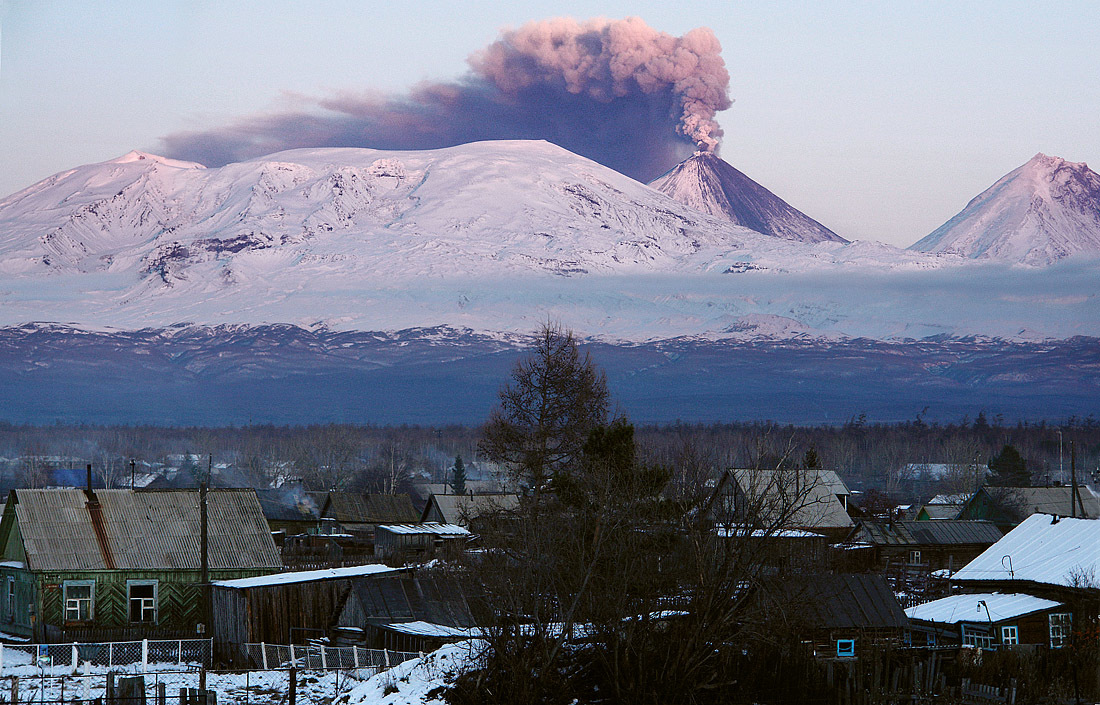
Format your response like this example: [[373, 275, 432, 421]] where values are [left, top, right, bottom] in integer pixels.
[[0, 669, 381, 705]]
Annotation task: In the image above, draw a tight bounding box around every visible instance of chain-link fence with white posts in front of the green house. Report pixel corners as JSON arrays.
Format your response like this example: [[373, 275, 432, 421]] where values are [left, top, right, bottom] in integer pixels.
[[0, 639, 211, 675]]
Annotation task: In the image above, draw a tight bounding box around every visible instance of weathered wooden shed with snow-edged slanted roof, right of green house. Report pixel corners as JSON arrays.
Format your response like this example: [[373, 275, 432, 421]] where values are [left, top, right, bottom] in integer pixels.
[[211, 564, 403, 665]]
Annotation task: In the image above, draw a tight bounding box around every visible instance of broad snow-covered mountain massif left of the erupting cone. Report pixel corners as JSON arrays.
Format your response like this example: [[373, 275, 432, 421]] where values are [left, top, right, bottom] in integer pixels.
[[0, 142, 783, 279]]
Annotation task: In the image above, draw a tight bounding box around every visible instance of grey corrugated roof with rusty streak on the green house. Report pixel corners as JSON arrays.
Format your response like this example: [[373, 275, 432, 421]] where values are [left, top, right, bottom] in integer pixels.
[[14, 489, 282, 571]]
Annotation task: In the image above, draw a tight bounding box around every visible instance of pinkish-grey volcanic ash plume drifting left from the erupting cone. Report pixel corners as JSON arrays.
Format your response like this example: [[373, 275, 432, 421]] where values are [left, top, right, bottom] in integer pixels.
[[164, 18, 730, 180]]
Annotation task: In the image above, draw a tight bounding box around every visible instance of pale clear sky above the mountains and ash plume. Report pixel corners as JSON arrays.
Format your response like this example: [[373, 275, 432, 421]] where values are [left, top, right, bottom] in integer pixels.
[[0, 0, 1100, 246]]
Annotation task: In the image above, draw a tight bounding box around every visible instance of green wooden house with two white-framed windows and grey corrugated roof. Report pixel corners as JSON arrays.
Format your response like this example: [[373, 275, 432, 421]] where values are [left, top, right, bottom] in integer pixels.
[[0, 489, 281, 642]]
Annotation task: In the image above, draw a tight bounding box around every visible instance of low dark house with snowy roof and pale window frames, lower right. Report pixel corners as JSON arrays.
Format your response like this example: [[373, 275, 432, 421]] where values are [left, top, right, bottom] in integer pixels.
[[905, 593, 1069, 649]]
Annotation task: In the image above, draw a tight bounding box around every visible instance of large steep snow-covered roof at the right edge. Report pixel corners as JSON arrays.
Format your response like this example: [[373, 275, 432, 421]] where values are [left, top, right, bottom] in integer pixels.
[[953, 514, 1100, 587]]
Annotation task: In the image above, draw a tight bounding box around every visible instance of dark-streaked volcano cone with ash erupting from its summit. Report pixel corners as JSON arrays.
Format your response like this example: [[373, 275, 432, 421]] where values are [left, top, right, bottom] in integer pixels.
[[650, 152, 847, 242]]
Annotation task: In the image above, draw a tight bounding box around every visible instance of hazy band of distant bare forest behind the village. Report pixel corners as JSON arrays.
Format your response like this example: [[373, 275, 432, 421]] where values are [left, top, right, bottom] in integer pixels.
[[0, 415, 1100, 503]]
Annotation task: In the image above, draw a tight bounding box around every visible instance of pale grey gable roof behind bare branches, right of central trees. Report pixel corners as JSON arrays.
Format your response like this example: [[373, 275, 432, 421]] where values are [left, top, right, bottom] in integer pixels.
[[712, 469, 853, 529]]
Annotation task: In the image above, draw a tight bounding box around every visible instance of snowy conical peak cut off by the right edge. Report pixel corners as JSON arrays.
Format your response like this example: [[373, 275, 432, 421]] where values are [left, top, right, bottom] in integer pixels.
[[911, 154, 1100, 265]]
